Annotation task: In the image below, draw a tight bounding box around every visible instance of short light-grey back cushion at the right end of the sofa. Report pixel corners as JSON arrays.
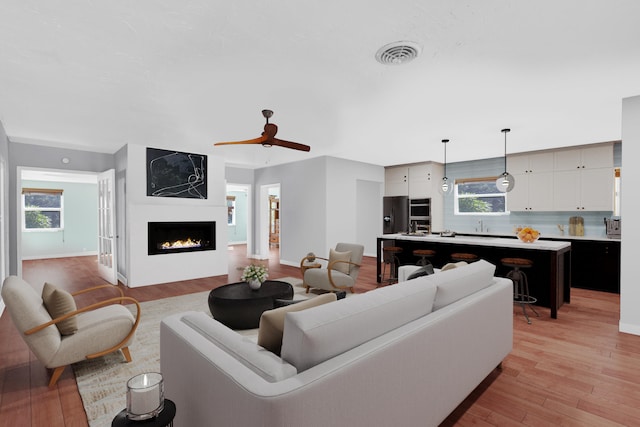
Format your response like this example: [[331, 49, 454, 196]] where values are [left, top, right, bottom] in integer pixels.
[[427, 259, 496, 311]]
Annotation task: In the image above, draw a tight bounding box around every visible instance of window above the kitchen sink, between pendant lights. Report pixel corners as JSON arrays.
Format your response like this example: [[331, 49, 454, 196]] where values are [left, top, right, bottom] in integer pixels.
[[454, 176, 509, 215]]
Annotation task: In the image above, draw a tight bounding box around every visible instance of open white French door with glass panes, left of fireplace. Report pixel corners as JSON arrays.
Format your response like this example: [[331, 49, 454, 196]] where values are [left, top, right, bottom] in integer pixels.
[[98, 169, 118, 285]]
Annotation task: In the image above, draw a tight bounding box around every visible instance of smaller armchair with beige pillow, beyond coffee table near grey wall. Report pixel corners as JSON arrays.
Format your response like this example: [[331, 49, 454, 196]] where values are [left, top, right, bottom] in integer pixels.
[[300, 243, 364, 293]]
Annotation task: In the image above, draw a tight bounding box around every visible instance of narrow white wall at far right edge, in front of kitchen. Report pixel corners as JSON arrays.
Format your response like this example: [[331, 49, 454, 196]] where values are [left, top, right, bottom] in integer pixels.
[[619, 96, 640, 335]]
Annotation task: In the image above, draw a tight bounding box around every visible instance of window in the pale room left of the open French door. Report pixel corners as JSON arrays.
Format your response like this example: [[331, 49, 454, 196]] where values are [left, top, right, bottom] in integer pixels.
[[22, 188, 64, 231]]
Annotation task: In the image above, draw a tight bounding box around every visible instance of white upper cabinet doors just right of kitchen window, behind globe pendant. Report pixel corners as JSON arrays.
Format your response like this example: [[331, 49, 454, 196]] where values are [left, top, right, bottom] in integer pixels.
[[507, 172, 554, 212]]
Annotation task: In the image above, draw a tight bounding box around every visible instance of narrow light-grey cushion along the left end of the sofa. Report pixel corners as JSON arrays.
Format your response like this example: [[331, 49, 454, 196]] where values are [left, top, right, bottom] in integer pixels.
[[182, 312, 297, 382]]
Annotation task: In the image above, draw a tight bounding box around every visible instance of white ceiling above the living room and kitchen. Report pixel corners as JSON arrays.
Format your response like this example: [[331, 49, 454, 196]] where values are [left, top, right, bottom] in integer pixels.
[[0, 0, 640, 167]]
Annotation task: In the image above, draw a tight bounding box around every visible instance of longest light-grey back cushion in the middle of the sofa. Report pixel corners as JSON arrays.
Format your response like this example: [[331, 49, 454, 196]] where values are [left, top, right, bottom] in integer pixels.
[[282, 276, 436, 371]]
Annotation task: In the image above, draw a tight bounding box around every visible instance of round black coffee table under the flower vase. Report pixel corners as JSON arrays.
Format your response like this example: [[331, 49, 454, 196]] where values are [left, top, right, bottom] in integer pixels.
[[209, 280, 293, 329]]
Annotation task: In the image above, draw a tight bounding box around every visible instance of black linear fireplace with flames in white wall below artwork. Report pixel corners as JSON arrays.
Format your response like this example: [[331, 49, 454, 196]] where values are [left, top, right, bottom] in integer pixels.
[[148, 221, 216, 255]]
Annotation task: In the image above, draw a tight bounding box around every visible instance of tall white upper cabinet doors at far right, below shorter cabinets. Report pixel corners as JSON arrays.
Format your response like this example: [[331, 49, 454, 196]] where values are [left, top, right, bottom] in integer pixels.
[[553, 168, 614, 211]]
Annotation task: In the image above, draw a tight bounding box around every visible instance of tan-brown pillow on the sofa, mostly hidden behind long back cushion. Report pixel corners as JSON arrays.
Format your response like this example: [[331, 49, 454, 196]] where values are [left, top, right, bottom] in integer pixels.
[[258, 292, 337, 356]]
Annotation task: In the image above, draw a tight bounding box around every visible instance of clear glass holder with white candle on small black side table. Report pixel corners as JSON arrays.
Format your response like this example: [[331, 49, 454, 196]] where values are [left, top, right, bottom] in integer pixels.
[[127, 372, 164, 421]]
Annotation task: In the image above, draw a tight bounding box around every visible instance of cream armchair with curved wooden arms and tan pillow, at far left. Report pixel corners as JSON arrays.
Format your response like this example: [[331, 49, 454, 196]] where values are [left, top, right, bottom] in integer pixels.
[[2, 276, 140, 387]]
